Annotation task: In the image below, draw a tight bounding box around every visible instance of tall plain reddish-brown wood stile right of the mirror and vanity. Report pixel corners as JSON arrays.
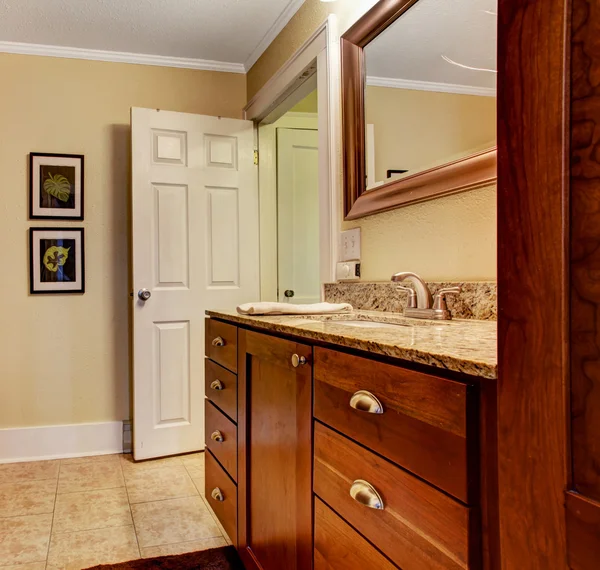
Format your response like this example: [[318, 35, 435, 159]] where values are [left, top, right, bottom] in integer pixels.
[[498, 0, 569, 570]]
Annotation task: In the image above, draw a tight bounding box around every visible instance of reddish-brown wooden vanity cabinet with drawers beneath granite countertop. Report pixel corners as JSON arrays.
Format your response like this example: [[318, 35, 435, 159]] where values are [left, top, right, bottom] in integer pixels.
[[206, 319, 490, 570]]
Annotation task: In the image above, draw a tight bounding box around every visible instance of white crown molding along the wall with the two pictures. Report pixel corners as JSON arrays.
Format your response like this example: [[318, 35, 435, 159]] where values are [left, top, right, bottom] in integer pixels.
[[0, 41, 246, 73]]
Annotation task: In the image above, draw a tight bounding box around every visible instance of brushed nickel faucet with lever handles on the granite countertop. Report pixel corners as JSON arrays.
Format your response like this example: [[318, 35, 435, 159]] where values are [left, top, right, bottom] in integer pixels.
[[392, 271, 462, 321]]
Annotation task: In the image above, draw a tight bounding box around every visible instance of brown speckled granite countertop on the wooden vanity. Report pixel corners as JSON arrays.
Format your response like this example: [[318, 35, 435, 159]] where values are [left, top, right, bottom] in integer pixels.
[[206, 311, 497, 379]]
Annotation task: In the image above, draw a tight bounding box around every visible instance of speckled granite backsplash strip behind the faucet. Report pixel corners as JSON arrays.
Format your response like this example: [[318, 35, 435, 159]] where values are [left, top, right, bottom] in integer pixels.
[[324, 281, 498, 321]]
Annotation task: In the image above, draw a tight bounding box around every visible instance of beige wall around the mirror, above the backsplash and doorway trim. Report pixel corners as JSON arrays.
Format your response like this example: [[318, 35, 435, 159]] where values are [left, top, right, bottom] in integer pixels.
[[247, 0, 496, 280]]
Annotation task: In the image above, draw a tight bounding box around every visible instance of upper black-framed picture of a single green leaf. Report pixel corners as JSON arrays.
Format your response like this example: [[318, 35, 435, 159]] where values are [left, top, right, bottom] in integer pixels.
[[29, 152, 83, 220]]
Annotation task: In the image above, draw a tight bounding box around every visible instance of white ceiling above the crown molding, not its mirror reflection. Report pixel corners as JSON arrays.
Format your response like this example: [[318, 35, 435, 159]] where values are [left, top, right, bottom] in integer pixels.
[[0, 0, 304, 72]]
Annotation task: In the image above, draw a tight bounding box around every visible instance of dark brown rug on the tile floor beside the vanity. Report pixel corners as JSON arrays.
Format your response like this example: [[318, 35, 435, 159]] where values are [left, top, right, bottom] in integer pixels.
[[88, 546, 244, 570]]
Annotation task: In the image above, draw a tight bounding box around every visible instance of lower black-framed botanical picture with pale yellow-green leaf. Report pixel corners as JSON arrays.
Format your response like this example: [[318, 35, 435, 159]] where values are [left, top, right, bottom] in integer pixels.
[[29, 228, 85, 294]]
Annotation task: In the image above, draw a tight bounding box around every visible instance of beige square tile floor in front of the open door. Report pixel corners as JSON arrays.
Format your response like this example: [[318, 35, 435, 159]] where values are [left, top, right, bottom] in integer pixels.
[[0, 453, 229, 570]]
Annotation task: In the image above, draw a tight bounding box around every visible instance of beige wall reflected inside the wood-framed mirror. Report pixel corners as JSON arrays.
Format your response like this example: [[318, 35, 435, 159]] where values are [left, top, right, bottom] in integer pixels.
[[365, 85, 496, 181]]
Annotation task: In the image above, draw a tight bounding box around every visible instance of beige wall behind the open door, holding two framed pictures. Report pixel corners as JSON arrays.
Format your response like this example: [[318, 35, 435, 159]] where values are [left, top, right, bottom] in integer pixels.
[[0, 54, 246, 427]]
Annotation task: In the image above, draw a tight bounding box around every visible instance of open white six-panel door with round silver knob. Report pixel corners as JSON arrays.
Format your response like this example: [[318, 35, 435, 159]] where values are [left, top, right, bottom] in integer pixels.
[[131, 108, 259, 459]]
